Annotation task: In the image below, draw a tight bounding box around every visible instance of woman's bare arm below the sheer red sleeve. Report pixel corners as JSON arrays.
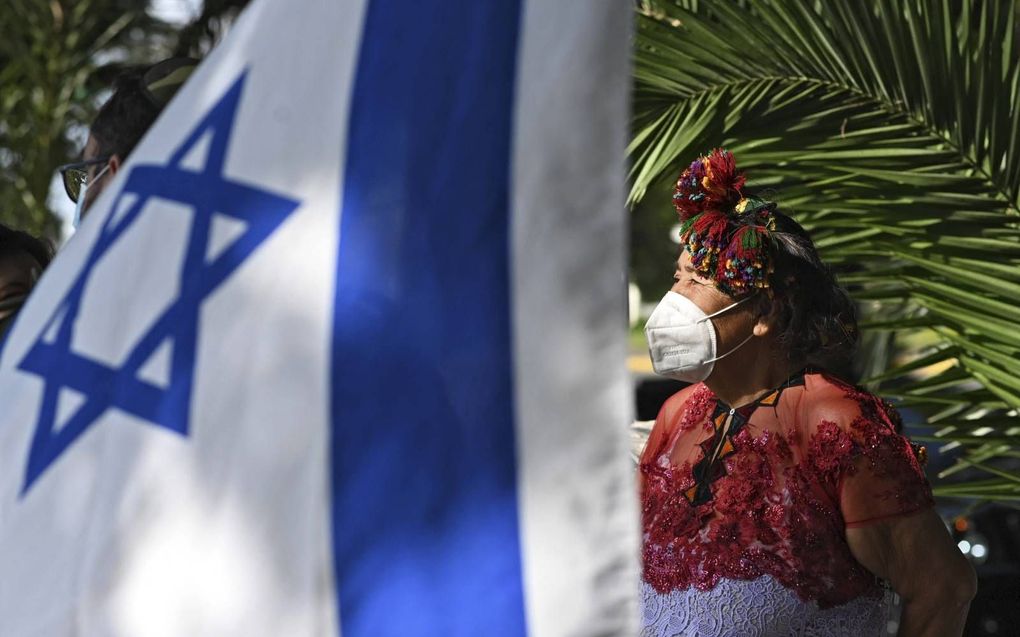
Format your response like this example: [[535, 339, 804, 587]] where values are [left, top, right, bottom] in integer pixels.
[[847, 509, 977, 637]]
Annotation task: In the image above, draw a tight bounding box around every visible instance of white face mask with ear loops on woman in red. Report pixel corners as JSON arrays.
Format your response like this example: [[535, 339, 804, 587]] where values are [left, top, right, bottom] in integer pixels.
[[645, 290, 755, 382]]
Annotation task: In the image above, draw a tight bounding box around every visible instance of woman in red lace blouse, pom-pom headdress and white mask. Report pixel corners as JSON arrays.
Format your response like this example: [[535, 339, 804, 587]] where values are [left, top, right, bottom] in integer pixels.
[[639, 151, 975, 637]]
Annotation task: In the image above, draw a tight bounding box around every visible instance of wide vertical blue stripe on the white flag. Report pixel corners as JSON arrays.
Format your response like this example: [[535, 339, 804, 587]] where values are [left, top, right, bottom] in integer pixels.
[[332, 0, 525, 637]]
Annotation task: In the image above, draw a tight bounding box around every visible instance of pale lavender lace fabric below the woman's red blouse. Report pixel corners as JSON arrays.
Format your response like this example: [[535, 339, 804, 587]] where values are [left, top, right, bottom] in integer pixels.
[[641, 575, 899, 637]]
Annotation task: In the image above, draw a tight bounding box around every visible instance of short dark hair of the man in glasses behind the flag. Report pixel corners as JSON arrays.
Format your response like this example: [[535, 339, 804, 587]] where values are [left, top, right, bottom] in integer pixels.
[[90, 69, 160, 161]]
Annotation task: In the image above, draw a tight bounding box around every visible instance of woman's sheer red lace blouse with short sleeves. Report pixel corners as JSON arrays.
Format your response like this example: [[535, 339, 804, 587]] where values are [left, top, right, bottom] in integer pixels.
[[640, 370, 933, 608]]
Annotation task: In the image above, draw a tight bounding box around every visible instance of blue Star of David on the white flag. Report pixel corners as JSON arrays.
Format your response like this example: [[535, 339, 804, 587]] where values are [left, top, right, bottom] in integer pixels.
[[18, 73, 298, 497]]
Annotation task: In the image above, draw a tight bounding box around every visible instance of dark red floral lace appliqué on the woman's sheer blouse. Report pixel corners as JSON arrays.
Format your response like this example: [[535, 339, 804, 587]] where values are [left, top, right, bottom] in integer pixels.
[[640, 373, 931, 611]]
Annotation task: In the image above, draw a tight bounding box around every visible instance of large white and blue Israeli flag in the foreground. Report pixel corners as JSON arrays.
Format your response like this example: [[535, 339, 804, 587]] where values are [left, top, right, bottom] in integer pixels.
[[0, 0, 640, 637]]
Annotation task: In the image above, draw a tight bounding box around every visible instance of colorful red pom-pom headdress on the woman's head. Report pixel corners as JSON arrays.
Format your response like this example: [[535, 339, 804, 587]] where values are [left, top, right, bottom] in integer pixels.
[[673, 149, 776, 296]]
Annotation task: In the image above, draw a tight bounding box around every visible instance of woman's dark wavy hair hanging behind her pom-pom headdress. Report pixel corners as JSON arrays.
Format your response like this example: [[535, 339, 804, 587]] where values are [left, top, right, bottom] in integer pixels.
[[753, 211, 859, 370]]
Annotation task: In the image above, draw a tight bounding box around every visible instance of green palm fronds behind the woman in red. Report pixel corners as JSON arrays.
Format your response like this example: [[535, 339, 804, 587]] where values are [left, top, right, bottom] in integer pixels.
[[628, 0, 1020, 501]]
